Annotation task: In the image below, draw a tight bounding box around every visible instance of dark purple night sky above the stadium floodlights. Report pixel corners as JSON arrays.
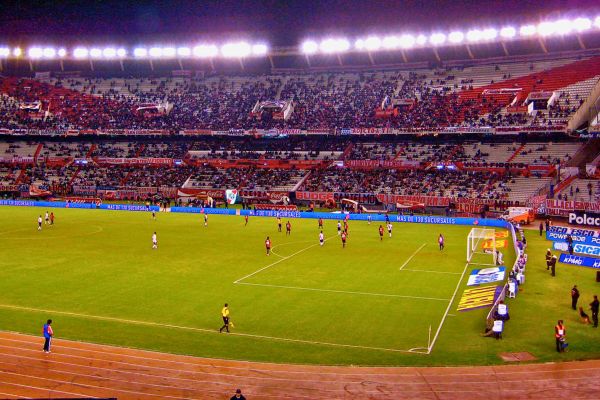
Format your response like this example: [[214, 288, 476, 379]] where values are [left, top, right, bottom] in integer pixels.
[[0, 0, 600, 45]]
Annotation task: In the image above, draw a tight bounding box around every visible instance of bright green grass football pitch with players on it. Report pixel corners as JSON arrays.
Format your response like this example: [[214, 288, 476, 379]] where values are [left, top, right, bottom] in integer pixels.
[[0, 207, 600, 365]]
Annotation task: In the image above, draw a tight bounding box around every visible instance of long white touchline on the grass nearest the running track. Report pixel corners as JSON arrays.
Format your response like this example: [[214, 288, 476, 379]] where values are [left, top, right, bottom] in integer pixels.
[[0, 299, 420, 353]]
